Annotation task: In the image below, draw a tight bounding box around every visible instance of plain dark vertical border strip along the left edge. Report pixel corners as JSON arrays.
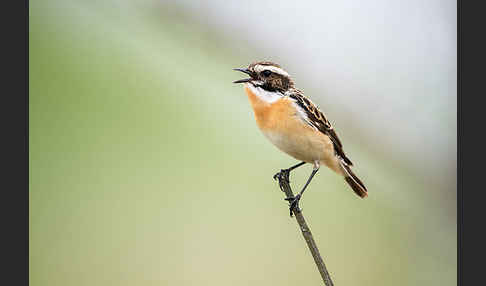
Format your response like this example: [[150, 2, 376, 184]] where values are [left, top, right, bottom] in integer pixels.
[[0, 0, 29, 285]]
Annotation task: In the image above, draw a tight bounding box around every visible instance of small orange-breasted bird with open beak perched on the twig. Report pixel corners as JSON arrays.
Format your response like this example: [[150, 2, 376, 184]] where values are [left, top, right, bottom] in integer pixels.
[[234, 61, 368, 215]]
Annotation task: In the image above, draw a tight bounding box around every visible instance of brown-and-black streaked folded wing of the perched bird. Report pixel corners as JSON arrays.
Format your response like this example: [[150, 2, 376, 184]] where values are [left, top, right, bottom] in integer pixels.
[[289, 90, 353, 166]]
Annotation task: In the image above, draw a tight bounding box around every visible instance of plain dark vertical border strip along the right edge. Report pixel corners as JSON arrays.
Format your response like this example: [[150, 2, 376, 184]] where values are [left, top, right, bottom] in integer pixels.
[[457, 0, 486, 285]]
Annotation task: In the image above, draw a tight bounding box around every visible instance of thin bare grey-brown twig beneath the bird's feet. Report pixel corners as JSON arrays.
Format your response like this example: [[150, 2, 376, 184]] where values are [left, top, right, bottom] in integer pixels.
[[276, 170, 334, 286]]
